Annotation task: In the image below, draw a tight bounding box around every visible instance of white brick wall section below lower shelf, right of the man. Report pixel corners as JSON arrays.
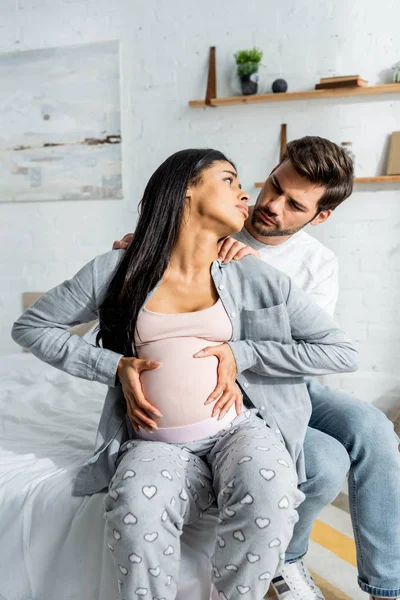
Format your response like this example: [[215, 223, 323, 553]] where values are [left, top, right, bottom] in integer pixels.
[[312, 186, 400, 381]]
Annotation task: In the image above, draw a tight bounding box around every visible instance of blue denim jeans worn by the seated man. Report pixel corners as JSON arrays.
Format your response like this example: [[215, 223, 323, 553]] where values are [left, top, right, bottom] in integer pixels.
[[286, 379, 400, 598]]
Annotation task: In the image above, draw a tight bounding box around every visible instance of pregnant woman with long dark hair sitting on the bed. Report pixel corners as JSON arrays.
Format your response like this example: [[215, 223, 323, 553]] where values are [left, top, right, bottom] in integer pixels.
[[13, 150, 356, 600]]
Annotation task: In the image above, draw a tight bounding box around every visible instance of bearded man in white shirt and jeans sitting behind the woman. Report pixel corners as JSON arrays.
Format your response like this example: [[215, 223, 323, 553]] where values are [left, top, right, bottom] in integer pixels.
[[114, 137, 400, 600]]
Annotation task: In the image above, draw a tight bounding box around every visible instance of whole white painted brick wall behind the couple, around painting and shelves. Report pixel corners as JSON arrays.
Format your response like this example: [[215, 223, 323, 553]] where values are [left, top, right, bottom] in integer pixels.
[[0, 0, 400, 392]]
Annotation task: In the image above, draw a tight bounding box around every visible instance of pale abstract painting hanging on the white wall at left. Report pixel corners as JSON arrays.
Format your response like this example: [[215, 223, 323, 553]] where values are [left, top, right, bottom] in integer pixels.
[[0, 41, 122, 202]]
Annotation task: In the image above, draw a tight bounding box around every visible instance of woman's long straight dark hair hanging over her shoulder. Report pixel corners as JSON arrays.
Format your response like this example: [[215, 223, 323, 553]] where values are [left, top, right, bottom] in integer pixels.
[[96, 149, 234, 356]]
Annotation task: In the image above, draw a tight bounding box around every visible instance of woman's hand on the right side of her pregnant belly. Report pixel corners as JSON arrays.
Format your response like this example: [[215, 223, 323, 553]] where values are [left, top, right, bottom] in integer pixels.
[[194, 344, 242, 419]]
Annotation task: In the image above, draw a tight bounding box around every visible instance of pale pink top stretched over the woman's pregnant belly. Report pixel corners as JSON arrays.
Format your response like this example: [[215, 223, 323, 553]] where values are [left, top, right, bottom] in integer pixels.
[[135, 299, 236, 442]]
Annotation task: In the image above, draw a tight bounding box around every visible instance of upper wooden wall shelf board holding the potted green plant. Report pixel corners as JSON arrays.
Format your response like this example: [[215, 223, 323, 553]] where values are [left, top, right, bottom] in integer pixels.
[[189, 83, 400, 108]]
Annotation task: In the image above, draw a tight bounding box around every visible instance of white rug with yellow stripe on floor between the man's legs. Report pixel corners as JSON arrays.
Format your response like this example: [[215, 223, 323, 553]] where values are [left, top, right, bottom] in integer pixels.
[[266, 493, 368, 600]]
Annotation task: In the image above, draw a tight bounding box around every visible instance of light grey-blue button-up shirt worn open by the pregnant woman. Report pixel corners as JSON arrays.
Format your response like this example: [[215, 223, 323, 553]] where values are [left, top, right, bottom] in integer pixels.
[[12, 250, 357, 495]]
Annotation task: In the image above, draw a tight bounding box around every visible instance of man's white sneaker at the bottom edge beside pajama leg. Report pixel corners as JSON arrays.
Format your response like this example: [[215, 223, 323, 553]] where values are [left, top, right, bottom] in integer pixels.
[[271, 560, 325, 600]]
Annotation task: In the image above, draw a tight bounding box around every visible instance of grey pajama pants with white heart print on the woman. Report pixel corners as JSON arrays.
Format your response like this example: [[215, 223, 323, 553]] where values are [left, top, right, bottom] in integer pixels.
[[104, 410, 304, 600]]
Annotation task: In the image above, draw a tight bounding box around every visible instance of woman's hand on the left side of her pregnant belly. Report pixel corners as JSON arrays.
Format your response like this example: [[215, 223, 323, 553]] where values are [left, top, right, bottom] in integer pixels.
[[117, 357, 162, 433]]
